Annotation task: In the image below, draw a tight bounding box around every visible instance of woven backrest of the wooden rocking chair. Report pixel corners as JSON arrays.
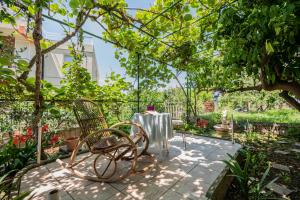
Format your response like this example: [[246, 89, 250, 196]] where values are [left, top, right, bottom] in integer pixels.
[[73, 99, 110, 148]]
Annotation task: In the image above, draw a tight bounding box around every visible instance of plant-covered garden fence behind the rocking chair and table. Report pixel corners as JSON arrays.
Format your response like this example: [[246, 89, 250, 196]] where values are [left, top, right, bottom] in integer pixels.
[[0, 100, 185, 142]]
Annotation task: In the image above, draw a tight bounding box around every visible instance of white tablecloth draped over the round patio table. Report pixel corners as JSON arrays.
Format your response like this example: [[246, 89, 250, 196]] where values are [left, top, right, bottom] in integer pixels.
[[131, 113, 173, 148]]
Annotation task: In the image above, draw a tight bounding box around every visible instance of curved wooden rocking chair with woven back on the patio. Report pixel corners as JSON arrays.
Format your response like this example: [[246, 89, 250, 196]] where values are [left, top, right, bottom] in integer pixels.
[[58, 99, 153, 182]]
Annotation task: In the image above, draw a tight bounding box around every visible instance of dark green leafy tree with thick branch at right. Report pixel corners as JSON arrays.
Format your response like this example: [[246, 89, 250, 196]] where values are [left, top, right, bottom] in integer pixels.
[[212, 0, 300, 111]]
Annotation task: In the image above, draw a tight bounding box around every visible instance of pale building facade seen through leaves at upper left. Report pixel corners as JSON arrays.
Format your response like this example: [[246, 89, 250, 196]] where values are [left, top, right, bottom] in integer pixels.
[[0, 20, 99, 86]]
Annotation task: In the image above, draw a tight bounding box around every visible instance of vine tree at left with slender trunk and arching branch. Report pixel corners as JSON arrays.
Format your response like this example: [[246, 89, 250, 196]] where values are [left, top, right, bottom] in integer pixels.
[[0, 0, 138, 136]]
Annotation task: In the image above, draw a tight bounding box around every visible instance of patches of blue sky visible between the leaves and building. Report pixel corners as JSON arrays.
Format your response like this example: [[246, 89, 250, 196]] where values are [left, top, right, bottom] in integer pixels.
[[43, 0, 184, 87]]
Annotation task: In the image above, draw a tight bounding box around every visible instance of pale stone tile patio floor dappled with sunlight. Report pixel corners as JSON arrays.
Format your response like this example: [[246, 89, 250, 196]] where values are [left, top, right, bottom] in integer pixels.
[[21, 134, 241, 200]]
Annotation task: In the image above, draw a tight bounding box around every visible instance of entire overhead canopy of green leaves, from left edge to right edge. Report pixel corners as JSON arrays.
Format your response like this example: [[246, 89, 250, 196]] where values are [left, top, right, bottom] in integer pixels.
[[0, 0, 300, 110]]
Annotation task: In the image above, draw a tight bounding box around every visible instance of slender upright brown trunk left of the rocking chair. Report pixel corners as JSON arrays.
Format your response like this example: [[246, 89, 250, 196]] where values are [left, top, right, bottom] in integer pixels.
[[32, 0, 43, 138]]
